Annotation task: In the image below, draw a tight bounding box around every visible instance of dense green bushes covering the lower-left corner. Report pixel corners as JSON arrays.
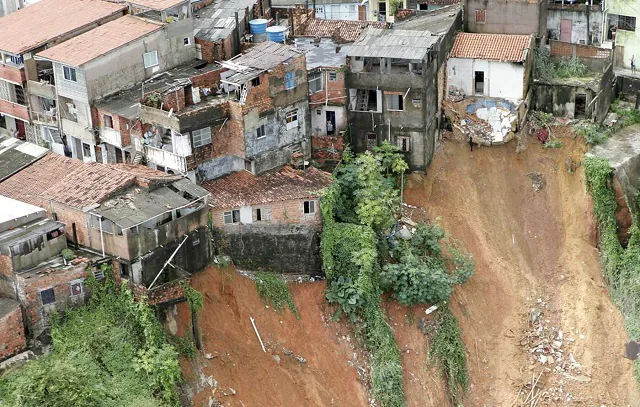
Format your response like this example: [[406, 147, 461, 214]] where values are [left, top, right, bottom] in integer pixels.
[[0, 270, 181, 407]]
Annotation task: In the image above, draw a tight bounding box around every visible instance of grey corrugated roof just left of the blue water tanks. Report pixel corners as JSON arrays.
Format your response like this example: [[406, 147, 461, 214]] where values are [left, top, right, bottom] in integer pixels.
[[193, 0, 258, 42]]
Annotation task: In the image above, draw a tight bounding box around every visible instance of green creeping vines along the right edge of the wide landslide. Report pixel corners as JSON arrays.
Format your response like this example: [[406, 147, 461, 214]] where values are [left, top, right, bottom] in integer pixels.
[[584, 157, 640, 381]]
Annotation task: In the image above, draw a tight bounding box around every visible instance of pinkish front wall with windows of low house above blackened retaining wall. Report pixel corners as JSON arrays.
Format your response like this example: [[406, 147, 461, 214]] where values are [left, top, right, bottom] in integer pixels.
[[212, 198, 321, 227]]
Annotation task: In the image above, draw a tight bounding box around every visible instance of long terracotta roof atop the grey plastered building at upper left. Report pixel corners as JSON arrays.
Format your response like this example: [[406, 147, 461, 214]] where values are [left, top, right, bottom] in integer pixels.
[[38, 15, 164, 66]]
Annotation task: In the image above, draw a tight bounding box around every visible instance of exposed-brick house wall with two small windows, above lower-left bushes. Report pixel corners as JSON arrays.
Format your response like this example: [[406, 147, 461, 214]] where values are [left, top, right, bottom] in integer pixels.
[[16, 260, 87, 336]]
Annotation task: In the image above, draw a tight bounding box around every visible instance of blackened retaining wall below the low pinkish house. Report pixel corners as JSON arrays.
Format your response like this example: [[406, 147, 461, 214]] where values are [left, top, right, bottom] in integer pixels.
[[223, 224, 322, 275]]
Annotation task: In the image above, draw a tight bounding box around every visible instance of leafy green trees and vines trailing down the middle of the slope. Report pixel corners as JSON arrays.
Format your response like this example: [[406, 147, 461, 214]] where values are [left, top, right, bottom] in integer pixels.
[[321, 142, 474, 407]]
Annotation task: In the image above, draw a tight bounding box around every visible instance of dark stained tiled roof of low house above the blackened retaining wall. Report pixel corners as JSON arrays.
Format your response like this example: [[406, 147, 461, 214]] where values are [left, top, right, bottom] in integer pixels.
[[201, 167, 331, 209]]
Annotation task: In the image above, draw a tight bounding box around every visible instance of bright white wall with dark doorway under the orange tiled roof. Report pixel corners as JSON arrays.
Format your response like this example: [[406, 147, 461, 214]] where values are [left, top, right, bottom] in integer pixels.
[[447, 58, 525, 100]]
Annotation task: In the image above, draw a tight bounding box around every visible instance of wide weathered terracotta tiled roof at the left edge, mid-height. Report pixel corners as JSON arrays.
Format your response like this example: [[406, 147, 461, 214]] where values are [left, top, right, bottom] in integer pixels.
[[0, 153, 180, 209]]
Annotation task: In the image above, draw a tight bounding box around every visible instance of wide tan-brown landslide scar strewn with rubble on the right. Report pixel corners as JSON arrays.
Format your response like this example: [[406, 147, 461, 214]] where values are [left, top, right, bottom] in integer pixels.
[[405, 135, 640, 407]]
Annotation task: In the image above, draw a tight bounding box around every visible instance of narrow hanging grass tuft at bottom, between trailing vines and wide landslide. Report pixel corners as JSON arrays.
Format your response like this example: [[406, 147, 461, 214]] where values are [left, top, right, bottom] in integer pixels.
[[427, 306, 469, 406]]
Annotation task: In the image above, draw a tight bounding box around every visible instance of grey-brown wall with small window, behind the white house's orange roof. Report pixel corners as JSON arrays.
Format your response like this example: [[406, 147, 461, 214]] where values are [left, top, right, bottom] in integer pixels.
[[464, 0, 547, 38]]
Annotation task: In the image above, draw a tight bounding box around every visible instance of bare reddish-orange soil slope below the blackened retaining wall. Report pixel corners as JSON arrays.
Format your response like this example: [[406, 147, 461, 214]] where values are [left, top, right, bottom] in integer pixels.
[[178, 268, 369, 407]]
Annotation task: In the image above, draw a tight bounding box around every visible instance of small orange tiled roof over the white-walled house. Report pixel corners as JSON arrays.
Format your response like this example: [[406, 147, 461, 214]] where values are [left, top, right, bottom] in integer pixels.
[[449, 33, 532, 62]]
